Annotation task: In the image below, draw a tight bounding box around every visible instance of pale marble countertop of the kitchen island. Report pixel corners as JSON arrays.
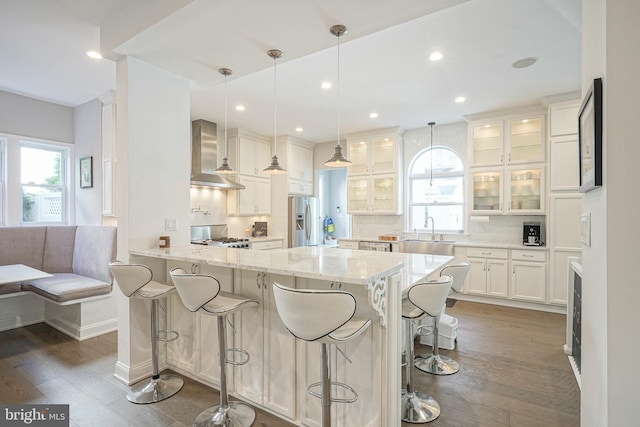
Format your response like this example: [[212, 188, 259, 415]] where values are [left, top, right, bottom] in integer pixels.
[[130, 245, 453, 290]]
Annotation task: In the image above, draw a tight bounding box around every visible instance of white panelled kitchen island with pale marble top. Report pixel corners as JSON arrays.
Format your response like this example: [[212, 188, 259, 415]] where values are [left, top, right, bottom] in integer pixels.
[[131, 245, 453, 427]]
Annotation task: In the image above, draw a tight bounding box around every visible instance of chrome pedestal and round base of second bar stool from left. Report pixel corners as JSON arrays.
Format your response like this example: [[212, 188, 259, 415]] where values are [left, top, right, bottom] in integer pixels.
[[193, 316, 256, 427]]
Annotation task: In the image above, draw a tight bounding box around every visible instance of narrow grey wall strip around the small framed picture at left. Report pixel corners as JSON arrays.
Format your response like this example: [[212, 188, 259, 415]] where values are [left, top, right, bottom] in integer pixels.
[[71, 99, 102, 225]]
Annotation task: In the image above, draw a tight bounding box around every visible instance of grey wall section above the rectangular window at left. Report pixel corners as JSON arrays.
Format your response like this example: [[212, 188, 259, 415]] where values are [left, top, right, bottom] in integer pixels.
[[0, 90, 74, 144]]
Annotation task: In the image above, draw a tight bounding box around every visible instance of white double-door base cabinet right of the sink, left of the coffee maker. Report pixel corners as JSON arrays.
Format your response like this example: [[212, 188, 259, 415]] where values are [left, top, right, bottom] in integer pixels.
[[464, 248, 509, 298]]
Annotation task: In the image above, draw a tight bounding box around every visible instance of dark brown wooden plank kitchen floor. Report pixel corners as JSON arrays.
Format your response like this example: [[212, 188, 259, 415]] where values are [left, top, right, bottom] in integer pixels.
[[0, 301, 580, 427]]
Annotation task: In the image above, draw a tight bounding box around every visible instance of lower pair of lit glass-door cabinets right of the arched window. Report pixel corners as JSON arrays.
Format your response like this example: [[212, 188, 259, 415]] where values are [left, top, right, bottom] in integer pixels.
[[470, 164, 546, 215]]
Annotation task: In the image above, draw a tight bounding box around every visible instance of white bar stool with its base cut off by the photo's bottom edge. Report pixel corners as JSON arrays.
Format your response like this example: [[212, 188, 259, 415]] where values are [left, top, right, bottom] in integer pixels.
[[273, 283, 371, 427]]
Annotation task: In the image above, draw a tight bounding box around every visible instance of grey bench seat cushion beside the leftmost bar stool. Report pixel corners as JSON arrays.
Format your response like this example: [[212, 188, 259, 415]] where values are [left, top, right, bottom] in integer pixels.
[[22, 273, 111, 303]]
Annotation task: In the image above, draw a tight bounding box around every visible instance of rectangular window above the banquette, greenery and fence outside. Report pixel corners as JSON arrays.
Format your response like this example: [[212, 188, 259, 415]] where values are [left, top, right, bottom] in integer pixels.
[[20, 141, 68, 224]]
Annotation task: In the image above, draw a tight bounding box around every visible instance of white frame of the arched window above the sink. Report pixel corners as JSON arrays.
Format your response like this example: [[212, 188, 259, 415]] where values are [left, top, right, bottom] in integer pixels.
[[406, 144, 467, 234]]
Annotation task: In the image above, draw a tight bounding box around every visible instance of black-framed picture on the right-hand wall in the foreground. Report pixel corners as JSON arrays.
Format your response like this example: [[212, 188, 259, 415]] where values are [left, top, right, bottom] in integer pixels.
[[578, 78, 602, 193]]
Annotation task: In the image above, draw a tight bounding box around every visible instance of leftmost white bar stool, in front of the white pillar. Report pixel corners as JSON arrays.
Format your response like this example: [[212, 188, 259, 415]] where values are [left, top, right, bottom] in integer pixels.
[[109, 261, 184, 403]]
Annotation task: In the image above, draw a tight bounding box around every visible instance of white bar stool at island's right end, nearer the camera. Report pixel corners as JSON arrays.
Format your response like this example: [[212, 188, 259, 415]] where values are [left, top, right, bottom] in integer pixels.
[[400, 276, 453, 424]]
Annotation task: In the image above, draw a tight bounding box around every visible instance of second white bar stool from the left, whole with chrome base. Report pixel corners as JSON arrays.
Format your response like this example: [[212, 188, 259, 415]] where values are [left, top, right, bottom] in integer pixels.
[[169, 268, 258, 427]]
